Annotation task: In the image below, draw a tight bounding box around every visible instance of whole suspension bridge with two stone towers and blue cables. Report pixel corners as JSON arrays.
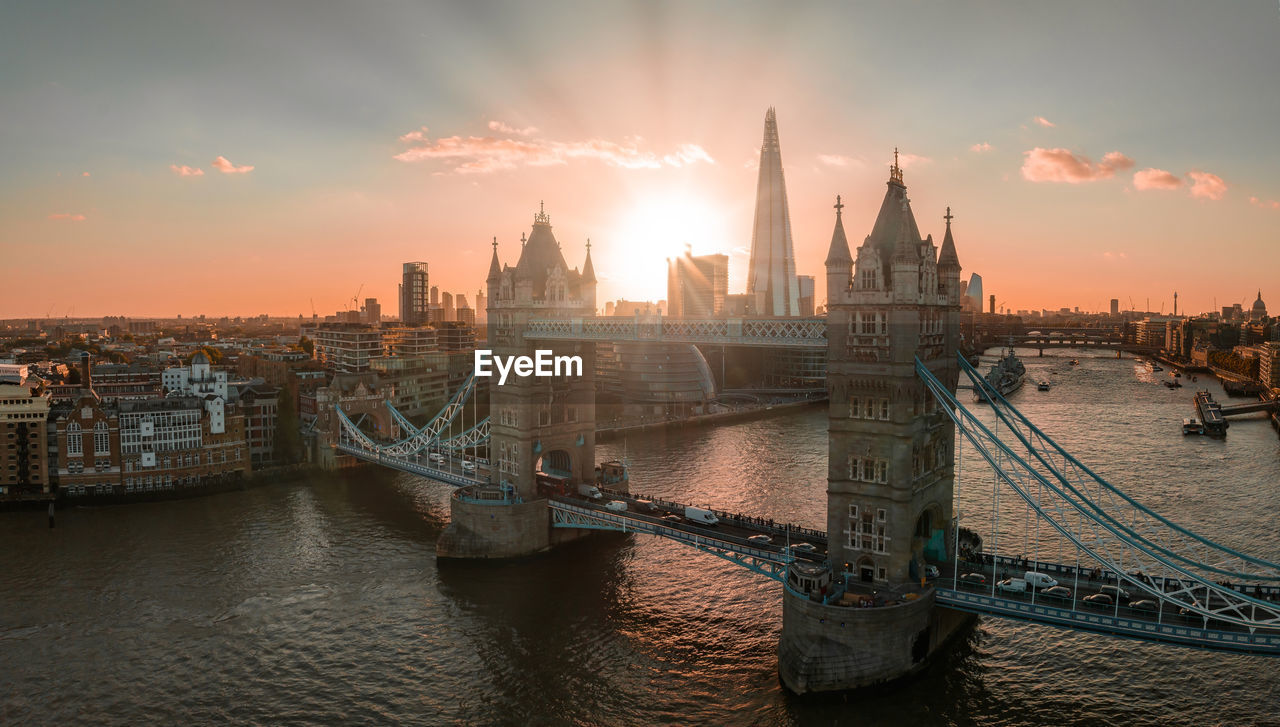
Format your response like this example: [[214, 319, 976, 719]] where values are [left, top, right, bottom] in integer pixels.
[[335, 135, 1280, 692]]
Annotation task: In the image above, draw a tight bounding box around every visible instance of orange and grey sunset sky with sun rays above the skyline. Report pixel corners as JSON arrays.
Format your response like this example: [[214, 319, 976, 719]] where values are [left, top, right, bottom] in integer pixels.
[[0, 0, 1280, 317]]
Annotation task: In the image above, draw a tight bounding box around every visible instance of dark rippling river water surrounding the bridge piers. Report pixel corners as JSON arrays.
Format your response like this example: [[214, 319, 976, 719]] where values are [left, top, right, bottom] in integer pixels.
[[0, 352, 1280, 726]]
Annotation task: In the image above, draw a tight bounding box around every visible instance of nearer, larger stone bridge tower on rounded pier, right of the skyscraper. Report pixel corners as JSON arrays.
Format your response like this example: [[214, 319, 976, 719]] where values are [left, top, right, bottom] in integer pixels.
[[778, 157, 963, 692]]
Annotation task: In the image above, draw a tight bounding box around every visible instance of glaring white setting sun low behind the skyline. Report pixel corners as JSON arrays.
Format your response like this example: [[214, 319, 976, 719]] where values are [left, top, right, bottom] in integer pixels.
[[596, 191, 732, 301]]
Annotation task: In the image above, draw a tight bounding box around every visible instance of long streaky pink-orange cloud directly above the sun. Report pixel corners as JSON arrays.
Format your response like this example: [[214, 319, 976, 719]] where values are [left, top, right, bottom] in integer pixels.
[[394, 132, 716, 174]]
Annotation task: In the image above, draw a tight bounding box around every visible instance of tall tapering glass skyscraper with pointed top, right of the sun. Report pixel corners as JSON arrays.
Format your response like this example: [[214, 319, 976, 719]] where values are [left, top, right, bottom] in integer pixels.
[[746, 108, 800, 316]]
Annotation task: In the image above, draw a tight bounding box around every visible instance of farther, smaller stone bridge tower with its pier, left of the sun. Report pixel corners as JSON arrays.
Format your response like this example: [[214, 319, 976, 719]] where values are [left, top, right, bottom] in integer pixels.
[[436, 207, 595, 558]]
